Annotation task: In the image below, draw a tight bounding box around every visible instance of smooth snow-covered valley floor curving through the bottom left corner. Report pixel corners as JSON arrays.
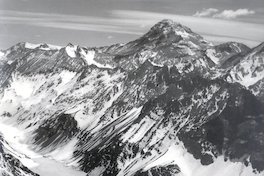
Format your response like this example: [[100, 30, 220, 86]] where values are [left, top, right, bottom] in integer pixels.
[[0, 122, 86, 176]]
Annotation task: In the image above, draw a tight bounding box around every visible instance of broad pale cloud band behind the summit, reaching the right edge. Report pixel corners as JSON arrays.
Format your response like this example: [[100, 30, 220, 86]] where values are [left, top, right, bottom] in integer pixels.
[[112, 10, 264, 47]]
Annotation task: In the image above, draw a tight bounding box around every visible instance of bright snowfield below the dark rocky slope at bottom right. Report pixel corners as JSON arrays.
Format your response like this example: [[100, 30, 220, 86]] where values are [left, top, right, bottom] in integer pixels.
[[144, 142, 264, 176]]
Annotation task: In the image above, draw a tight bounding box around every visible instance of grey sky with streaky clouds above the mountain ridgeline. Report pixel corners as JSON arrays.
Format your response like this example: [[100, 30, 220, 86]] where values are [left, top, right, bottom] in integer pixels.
[[0, 0, 264, 50]]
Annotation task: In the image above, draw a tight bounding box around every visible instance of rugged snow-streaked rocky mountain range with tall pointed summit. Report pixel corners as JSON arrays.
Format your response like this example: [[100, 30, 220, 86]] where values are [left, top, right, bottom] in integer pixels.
[[0, 20, 264, 176]]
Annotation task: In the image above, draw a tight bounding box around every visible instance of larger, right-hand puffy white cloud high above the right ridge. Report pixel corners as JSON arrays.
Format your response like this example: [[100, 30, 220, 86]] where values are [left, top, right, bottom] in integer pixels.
[[213, 9, 255, 19]]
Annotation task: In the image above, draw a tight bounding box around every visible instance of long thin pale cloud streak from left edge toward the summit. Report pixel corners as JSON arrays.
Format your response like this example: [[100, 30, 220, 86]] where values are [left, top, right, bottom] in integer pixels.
[[0, 10, 142, 35]]
